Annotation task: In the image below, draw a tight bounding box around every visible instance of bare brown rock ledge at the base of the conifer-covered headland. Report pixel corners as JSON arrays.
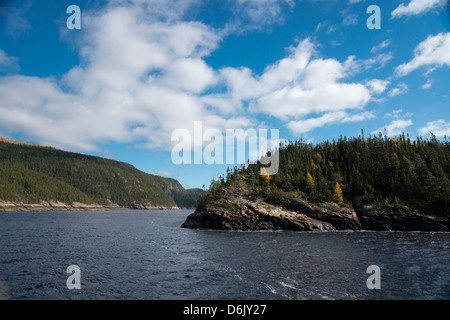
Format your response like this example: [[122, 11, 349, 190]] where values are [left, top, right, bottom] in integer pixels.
[[182, 197, 450, 231]]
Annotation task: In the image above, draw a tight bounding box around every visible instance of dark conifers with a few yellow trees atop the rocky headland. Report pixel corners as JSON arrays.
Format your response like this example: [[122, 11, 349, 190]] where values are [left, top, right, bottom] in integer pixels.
[[199, 134, 450, 212]]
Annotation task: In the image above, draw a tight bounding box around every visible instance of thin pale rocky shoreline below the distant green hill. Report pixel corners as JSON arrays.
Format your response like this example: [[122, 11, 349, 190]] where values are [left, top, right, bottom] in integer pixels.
[[0, 201, 179, 211]]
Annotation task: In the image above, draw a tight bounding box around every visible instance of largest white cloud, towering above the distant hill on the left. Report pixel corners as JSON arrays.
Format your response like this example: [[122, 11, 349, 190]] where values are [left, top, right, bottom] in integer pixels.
[[0, 4, 230, 151]]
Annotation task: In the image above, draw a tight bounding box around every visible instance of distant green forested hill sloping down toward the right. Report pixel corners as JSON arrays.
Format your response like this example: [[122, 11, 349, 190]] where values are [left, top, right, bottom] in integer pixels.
[[0, 138, 196, 208]]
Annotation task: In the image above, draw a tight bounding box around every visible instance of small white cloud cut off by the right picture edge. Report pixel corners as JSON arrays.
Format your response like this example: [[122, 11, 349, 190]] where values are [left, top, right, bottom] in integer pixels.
[[395, 32, 450, 76]]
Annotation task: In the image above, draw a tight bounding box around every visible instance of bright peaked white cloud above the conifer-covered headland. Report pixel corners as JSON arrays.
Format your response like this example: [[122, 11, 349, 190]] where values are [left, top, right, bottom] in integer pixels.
[[228, 39, 370, 120]]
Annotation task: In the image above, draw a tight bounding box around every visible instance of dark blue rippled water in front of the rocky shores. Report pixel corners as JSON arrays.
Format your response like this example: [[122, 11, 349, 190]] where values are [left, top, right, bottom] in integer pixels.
[[0, 210, 450, 300]]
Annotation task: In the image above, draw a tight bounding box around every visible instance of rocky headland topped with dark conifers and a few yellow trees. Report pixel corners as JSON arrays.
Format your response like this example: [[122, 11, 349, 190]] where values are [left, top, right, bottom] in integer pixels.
[[182, 132, 450, 231]]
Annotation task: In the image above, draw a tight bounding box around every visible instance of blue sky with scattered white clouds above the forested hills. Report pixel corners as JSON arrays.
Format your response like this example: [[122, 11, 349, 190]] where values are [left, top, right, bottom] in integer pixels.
[[0, 0, 450, 188]]
